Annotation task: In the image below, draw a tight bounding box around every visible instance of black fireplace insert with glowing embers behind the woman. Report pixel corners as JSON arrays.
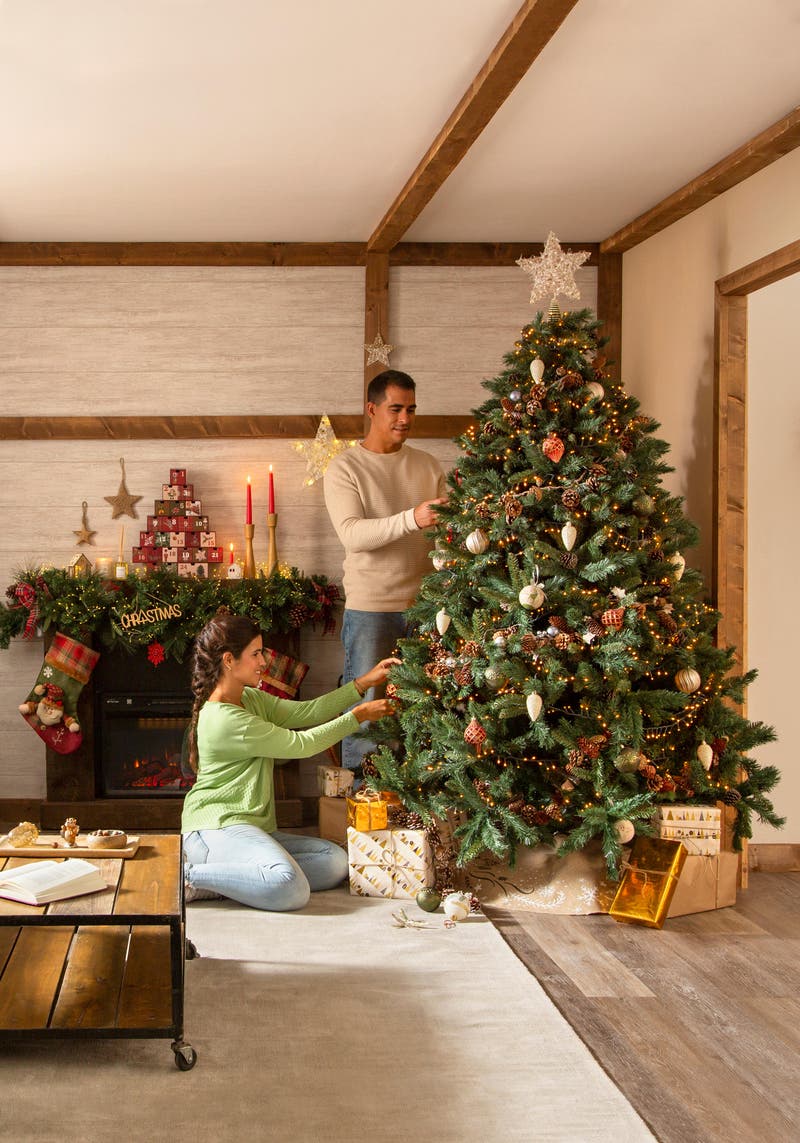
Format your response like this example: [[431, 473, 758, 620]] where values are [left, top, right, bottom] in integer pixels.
[[95, 690, 194, 798]]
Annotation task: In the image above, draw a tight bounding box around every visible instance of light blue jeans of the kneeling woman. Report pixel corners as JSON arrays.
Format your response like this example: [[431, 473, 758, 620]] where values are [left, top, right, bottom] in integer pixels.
[[183, 825, 347, 912]]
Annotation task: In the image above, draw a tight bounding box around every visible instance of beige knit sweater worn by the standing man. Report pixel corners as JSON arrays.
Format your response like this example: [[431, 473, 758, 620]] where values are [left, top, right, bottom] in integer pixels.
[[325, 445, 447, 612]]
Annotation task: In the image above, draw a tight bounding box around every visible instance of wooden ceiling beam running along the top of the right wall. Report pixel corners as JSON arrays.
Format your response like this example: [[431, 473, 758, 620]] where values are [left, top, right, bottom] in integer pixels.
[[600, 107, 800, 254]]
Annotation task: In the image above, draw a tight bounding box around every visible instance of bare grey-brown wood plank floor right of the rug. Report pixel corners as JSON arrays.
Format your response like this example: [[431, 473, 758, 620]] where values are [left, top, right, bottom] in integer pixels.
[[487, 873, 800, 1143]]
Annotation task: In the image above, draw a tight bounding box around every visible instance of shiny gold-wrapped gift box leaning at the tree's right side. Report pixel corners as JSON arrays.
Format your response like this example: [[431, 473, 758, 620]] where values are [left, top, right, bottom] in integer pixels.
[[609, 838, 687, 928]]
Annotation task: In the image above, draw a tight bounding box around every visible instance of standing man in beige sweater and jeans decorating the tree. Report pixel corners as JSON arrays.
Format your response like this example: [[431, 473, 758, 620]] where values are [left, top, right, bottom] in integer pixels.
[[325, 369, 447, 769]]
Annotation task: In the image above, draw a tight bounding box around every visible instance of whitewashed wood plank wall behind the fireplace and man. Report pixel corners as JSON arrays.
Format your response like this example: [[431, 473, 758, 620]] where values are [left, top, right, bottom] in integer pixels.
[[0, 265, 597, 798]]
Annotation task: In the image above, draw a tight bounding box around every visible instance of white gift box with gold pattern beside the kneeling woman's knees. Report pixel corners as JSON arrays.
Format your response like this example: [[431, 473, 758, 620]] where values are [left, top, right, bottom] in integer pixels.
[[347, 827, 434, 898]]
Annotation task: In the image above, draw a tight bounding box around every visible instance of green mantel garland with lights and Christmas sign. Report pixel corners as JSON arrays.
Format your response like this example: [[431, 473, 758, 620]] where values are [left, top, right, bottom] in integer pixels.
[[0, 565, 341, 662]]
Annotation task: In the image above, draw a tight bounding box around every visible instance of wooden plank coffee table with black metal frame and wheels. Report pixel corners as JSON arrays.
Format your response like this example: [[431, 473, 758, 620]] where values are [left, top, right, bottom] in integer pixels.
[[0, 834, 197, 1071]]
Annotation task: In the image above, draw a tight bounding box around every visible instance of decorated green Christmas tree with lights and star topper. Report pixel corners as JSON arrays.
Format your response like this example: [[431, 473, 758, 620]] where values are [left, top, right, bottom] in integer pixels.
[[367, 238, 783, 874]]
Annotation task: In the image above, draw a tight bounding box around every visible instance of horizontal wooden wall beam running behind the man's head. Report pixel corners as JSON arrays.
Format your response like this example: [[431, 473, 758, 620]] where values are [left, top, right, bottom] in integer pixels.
[[0, 414, 472, 440]]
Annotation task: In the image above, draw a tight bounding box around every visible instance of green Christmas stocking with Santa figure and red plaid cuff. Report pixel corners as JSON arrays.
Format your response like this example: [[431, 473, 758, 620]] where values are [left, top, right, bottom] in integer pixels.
[[19, 632, 99, 754]]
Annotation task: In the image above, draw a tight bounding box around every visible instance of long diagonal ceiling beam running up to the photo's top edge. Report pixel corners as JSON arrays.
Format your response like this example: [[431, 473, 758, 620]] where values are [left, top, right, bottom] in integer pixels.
[[367, 0, 577, 251]]
